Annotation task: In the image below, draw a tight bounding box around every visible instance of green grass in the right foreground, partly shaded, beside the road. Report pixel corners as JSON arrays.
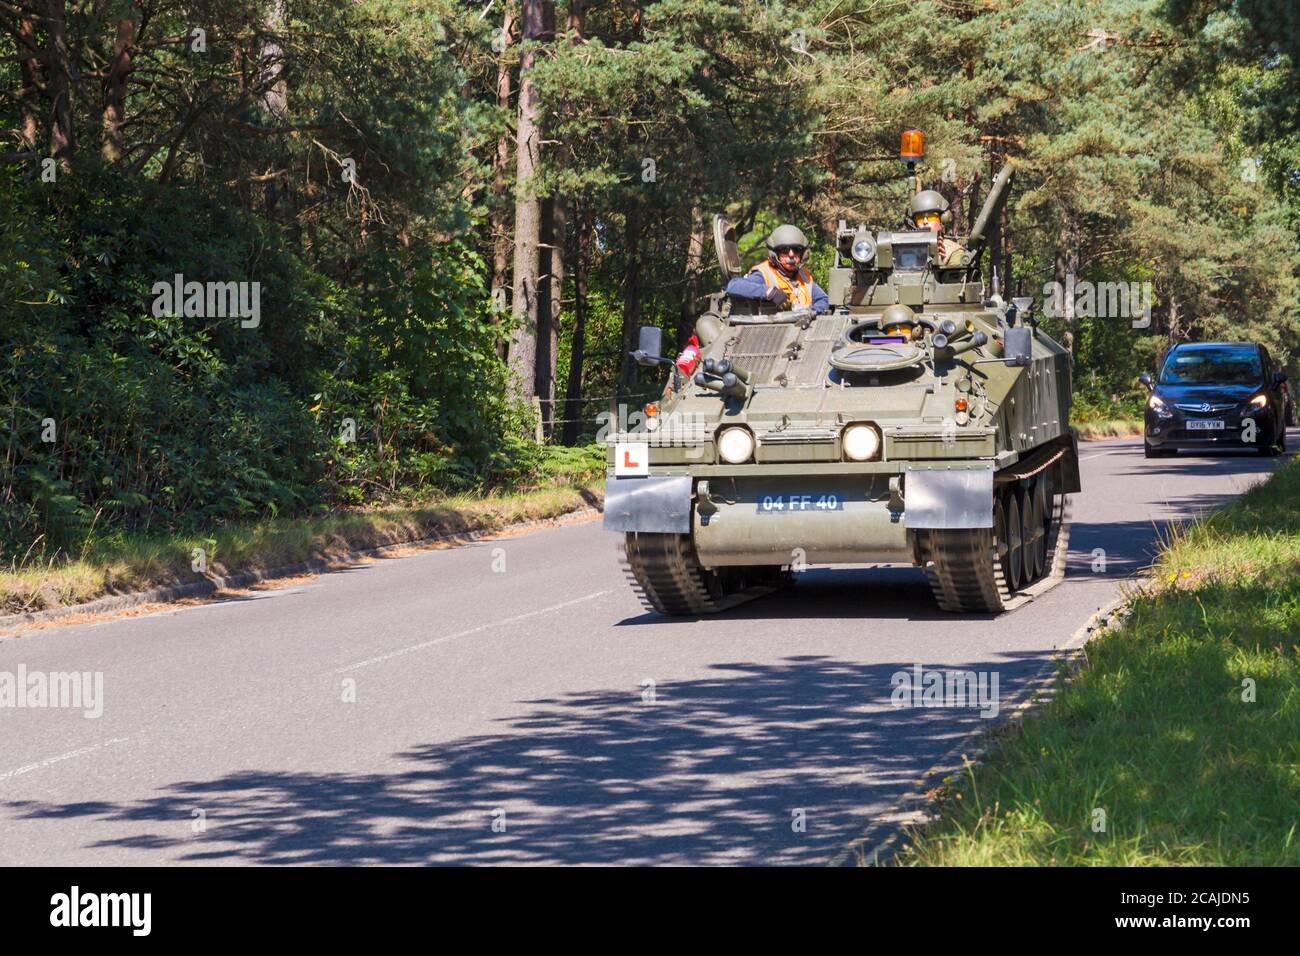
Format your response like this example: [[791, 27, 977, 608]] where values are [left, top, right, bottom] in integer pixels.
[[896, 462, 1300, 866]]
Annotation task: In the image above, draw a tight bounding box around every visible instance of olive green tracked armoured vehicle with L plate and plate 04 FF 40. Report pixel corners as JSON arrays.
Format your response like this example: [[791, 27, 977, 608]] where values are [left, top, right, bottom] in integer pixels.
[[605, 148, 1079, 615]]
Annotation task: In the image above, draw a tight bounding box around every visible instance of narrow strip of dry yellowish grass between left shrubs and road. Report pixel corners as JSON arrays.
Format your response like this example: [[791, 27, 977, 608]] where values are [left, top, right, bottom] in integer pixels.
[[0, 481, 605, 614]]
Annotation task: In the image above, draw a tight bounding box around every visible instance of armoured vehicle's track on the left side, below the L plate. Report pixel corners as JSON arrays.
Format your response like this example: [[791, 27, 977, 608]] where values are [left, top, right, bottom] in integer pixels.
[[621, 531, 779, 617]]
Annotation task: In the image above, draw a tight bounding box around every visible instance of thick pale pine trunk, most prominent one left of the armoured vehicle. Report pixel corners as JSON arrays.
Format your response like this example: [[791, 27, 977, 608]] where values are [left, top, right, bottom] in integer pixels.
[[510, 0, 543, 399]]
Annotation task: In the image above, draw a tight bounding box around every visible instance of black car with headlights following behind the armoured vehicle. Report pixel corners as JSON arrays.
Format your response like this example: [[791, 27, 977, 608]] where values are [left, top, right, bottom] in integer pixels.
[[1141, 342, 1287, 458]]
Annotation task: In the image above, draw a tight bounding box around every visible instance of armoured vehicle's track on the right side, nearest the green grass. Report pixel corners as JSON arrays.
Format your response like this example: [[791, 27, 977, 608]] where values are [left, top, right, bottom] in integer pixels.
[[919, 494, 1070, 614]]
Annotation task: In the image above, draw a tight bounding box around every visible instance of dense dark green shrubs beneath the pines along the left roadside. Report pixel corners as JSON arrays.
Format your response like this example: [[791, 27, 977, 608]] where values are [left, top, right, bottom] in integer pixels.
[[0, 161, 527, 555]]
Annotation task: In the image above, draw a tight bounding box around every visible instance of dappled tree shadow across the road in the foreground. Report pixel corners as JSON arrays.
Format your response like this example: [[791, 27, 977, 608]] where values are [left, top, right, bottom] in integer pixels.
[[7, 653, 1052, 864]]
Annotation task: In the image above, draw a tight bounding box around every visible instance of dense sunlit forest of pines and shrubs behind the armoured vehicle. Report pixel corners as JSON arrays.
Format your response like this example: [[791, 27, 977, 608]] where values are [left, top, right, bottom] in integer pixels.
[[0, 0, 1300, 559]]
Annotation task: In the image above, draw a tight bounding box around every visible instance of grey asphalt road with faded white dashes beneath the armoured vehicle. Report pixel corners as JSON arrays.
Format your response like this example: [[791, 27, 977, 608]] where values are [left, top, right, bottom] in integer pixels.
[[0, 433, 1297, 865]]
